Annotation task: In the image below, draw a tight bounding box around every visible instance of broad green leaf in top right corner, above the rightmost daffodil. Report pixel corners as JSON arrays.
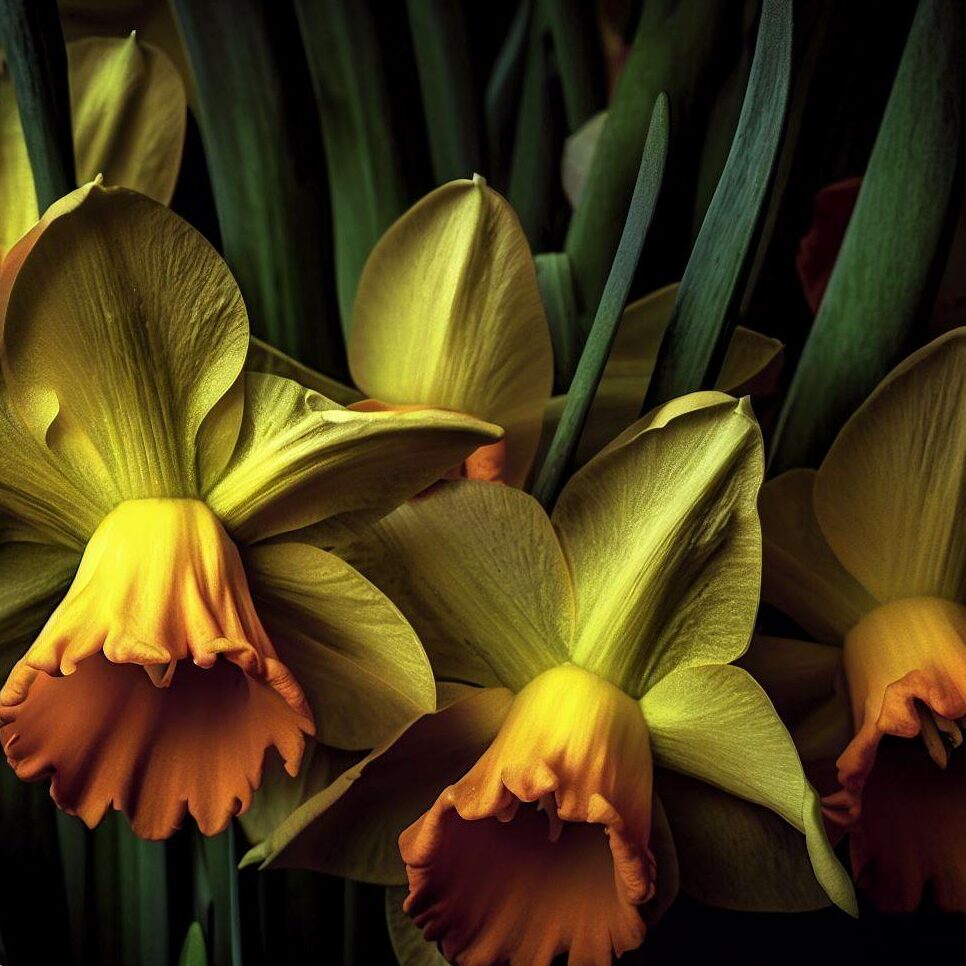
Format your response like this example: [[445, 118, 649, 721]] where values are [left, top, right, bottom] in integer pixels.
[[770, 0, 966, 473]]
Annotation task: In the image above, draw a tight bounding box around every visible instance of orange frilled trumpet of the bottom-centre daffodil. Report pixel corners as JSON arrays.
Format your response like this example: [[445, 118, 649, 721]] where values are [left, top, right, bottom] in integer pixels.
[[399, 666, 655, 966]]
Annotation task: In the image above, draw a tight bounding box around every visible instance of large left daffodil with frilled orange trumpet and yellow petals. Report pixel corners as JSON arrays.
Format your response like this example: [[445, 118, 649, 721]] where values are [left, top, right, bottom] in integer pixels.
[[0, 183, 499, 838]]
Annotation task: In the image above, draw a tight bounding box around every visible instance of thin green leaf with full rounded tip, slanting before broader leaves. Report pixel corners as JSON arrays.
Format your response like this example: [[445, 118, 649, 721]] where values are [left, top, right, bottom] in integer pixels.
[[533, 94, 669, 509]]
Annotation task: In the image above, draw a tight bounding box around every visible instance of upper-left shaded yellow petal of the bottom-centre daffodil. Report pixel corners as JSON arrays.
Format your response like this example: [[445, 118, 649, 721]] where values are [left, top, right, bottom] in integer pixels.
[[345, 480, 574, 690]]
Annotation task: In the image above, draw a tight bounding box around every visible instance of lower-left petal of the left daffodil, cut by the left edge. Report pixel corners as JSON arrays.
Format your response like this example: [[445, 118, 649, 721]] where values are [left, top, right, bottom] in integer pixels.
[[0, 541, 80, 679]]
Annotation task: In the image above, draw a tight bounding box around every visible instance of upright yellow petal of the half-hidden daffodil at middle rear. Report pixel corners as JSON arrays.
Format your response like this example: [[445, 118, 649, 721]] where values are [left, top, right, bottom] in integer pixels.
[[348, 178, 553, 485]]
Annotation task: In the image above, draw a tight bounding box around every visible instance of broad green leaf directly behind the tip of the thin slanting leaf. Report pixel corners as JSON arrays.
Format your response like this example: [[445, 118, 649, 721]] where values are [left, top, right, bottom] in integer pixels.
[[565, 0, 735, 337]]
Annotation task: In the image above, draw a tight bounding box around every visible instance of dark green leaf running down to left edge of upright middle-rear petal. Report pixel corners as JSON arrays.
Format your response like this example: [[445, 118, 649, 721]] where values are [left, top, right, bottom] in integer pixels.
[[295, 0, 407, 336]]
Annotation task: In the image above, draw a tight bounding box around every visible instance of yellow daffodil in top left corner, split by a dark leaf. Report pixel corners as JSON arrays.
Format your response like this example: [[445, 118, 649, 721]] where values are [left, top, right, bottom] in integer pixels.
[[0, 34, 187, 257]]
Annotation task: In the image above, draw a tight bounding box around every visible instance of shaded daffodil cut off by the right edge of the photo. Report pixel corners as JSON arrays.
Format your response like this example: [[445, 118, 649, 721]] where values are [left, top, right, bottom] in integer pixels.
[[752, 328, 966, 911]]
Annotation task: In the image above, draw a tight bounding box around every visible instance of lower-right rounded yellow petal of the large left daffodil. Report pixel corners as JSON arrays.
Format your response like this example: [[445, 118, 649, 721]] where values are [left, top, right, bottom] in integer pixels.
[[244, 543, 436, 749]]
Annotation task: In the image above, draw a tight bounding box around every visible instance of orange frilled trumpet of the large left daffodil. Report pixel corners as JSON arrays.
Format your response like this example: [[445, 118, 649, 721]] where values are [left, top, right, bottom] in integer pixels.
[[0, 500, 314, 839]]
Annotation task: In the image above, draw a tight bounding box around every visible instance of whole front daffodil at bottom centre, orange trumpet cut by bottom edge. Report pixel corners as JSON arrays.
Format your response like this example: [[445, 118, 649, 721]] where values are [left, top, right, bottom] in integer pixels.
[[247, 392, 854, 966]]
